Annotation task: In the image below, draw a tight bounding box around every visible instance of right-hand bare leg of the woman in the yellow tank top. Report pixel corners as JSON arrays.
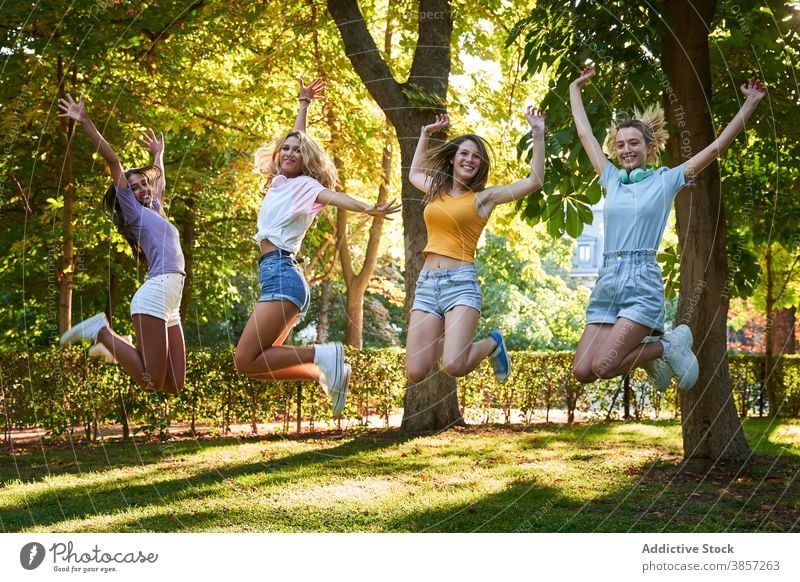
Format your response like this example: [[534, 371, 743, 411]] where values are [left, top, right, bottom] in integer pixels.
[[443, 305, 497, 378]]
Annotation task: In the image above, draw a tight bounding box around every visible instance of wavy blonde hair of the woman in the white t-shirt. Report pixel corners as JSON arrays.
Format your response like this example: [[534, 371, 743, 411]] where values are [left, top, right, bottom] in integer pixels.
[[253, 131, 339, 190]]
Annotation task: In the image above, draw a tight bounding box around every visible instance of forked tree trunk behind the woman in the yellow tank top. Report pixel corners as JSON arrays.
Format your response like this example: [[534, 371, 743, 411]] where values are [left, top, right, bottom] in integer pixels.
[[328, 0, 463, 433]]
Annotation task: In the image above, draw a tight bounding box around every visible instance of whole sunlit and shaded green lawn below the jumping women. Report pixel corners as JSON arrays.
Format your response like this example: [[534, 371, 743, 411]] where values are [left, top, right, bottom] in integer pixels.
[[0, 419, 800, 532]]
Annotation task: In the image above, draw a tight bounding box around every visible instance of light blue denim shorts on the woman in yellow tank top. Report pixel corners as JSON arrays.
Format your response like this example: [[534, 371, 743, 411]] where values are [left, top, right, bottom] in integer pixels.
[[411, 265, 483, 319]]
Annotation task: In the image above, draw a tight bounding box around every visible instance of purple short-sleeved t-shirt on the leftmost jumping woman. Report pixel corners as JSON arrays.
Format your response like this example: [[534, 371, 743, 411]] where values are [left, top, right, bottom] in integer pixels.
[[116, 187, 186, 277]]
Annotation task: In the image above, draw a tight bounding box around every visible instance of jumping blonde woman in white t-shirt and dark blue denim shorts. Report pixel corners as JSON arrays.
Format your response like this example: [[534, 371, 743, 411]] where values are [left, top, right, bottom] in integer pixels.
[[234, 79, 399, 415]]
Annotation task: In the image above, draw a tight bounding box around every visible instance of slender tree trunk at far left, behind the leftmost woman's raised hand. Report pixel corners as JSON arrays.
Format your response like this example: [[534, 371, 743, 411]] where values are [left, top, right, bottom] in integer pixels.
[[57, 57, 76, 334]]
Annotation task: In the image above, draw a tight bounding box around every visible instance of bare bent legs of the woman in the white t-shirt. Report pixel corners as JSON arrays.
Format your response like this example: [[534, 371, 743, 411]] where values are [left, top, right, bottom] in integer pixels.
[[234, 301, 320, 380]]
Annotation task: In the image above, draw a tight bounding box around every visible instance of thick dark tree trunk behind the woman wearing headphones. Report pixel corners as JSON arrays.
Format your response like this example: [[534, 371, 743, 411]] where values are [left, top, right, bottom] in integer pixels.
[[662, 0, 750, 462]]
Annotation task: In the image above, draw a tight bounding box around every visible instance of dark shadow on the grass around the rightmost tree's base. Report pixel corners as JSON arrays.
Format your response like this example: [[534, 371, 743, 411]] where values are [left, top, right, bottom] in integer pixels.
[[392, 456, 800, 533]]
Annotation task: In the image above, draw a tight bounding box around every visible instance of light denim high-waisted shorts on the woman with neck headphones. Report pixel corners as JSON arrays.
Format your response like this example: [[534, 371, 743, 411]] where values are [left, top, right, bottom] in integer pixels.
[[586, 250, 664, 334]]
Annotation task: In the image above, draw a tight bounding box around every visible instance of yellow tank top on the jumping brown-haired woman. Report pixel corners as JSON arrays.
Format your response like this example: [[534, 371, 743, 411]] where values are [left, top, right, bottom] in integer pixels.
[[422, 192, 487, 263]]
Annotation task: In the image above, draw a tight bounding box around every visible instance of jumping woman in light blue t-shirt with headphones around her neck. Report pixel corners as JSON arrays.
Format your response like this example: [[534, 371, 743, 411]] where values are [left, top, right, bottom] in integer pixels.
[[570, 67, 766, 391]]
